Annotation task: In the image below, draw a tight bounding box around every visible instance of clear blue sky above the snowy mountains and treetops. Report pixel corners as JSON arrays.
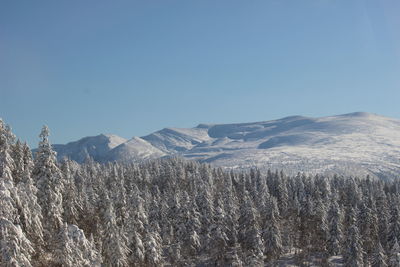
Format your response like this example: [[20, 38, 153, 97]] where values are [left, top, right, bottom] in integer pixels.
[[0, 0, 400, 147]]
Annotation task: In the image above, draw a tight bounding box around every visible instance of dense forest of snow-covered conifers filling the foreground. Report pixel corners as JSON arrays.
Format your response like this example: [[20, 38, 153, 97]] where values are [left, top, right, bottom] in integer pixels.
[[0, 120, 400, 267]]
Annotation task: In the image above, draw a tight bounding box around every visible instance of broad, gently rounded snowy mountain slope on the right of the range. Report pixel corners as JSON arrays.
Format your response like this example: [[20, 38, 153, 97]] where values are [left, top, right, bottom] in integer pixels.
[[185, 113, 400, 179]]
